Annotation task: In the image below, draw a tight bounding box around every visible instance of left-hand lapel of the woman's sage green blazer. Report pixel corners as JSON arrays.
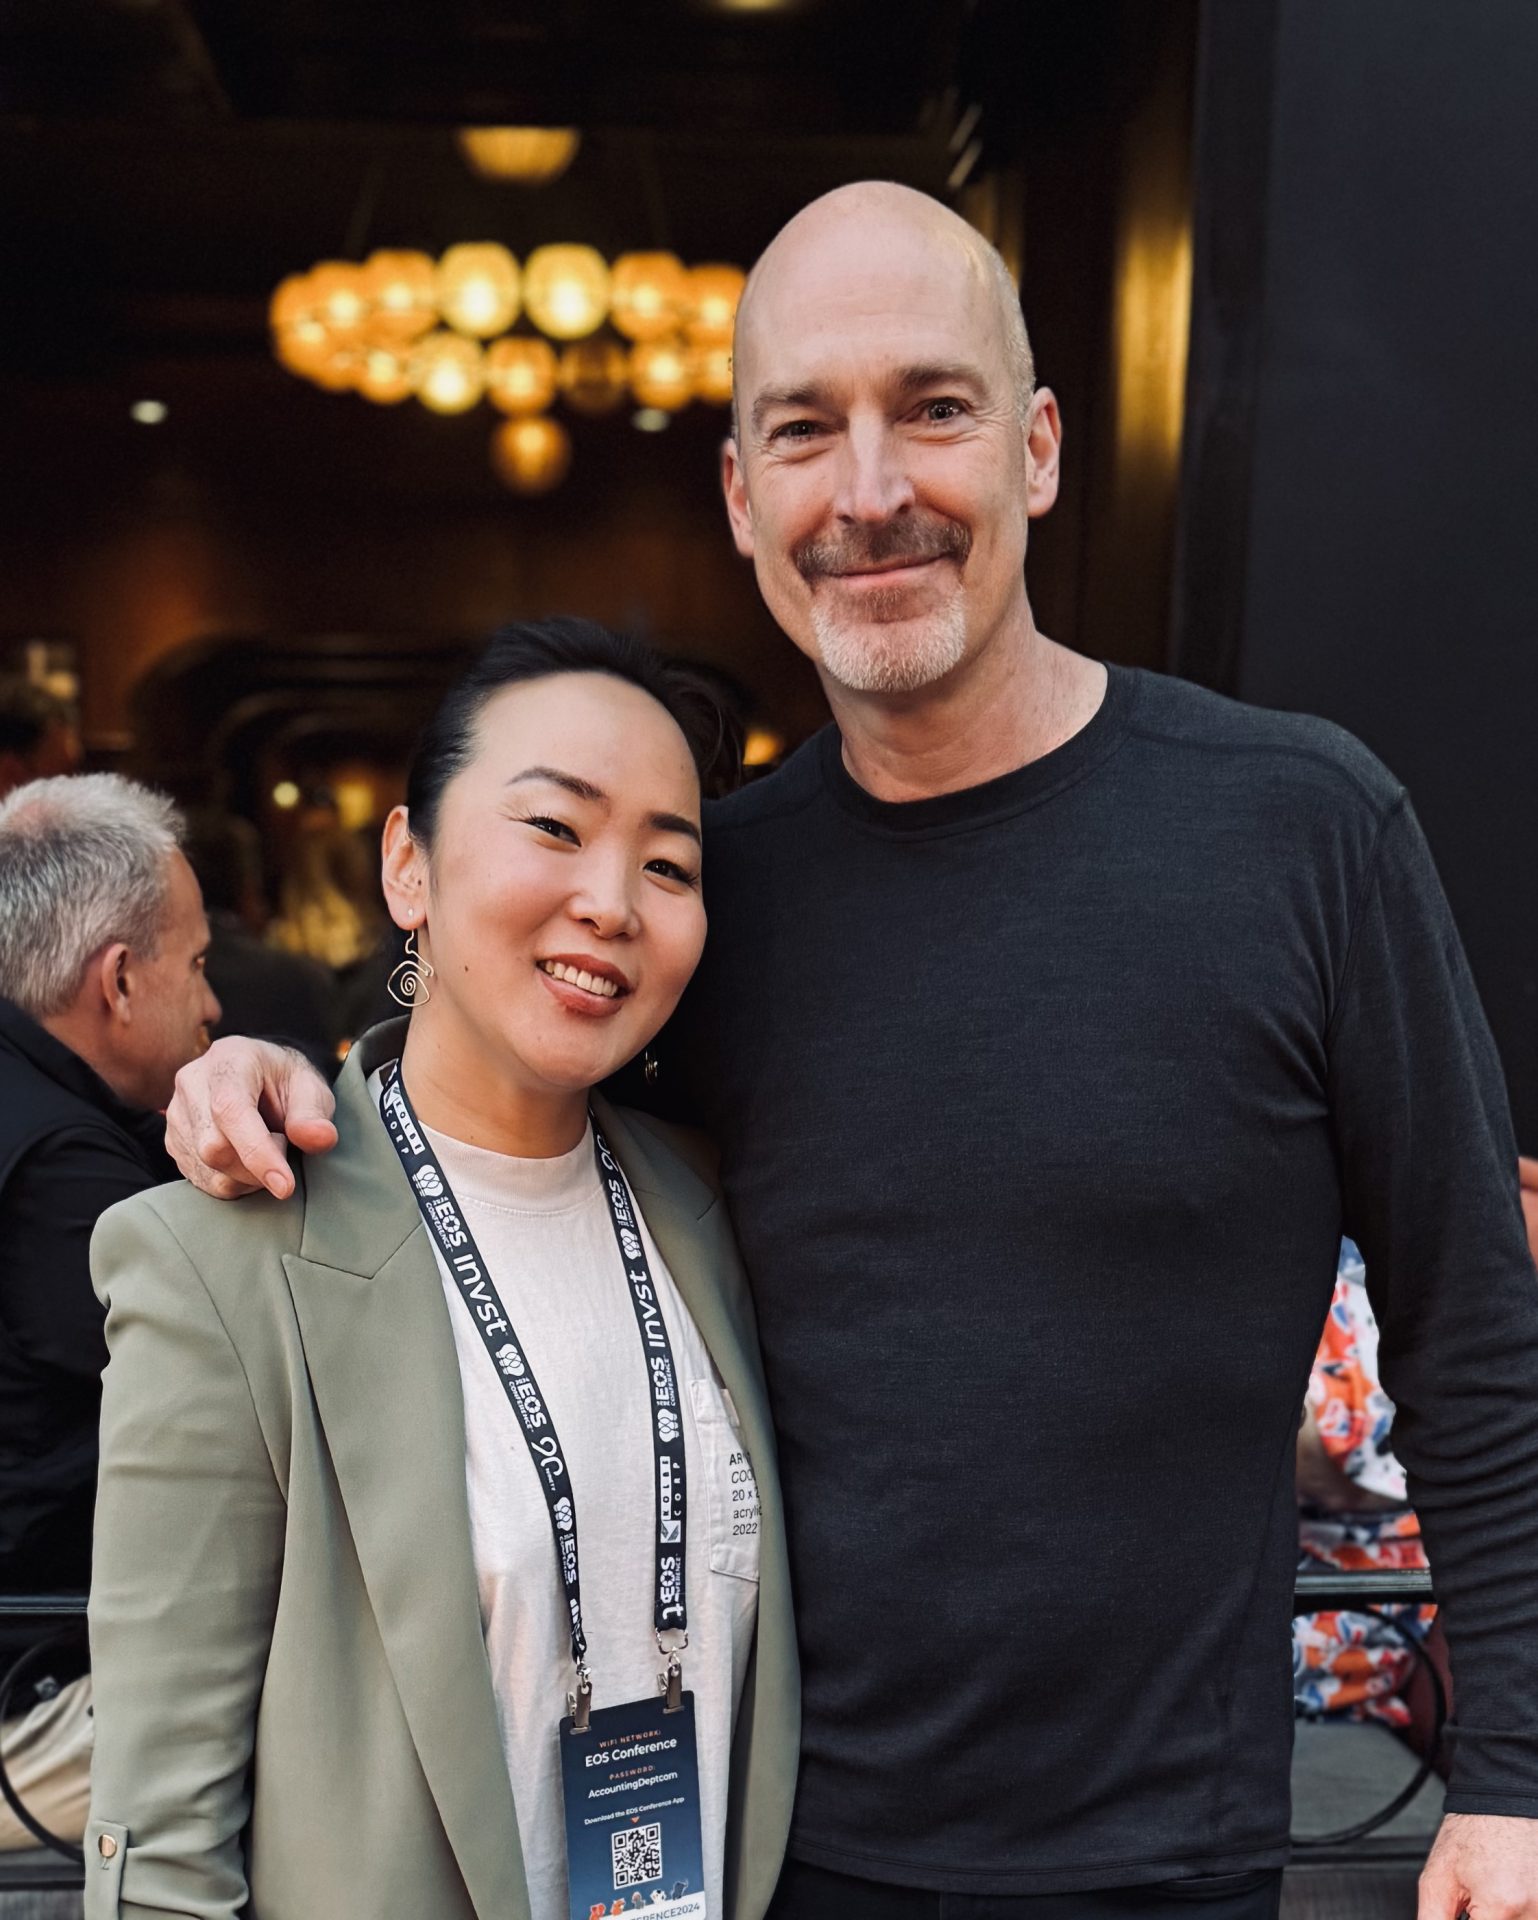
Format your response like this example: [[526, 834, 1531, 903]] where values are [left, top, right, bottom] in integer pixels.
[[284, 1021, 528, 1920]]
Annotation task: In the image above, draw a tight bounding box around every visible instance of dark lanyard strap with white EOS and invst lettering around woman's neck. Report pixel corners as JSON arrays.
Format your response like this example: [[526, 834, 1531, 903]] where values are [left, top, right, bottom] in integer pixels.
[[378, 1060, 689, 1728]]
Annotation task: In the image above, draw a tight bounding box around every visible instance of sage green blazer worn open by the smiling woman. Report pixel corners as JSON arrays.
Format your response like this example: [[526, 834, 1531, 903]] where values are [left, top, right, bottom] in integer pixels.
[[84, 1021, 799, 1920]]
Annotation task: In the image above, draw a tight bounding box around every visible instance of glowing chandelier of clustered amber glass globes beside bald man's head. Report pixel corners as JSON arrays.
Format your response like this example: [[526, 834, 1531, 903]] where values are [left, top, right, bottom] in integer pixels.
[[269, 240, 745, 493]]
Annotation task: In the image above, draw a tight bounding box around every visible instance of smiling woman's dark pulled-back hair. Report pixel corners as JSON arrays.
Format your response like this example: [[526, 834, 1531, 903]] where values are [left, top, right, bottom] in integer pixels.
[[405, 618, 741, 847]]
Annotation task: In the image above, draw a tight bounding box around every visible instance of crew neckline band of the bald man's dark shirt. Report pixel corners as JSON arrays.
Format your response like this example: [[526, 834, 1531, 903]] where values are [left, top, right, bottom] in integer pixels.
[[818, 660, 1137, 835]]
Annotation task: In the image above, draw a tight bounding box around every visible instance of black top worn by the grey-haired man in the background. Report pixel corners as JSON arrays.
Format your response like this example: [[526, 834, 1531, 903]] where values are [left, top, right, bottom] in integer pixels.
[[0, 1000, 175, 1594]]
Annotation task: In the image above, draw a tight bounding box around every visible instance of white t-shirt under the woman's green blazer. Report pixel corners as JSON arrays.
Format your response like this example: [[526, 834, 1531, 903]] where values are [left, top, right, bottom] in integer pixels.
[[372, 1075, 758, 1920]]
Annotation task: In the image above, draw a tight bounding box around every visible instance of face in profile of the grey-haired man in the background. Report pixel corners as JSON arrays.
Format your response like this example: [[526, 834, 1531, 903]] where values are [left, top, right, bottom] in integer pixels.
[[111, 852, 219, 1108]]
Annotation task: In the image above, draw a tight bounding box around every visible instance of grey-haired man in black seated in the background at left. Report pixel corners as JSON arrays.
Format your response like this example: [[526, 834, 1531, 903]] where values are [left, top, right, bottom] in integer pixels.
[[0, 774, 219, 1849]]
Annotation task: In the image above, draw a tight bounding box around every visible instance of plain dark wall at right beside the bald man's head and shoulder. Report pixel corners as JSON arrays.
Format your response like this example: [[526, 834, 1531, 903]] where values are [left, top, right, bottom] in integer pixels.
[[1173, 0, 1538, 1152]]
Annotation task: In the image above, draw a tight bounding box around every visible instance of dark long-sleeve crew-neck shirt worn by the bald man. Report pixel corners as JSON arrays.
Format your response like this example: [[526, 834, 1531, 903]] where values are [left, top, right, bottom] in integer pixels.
[[661, 668, 1538, 1893]]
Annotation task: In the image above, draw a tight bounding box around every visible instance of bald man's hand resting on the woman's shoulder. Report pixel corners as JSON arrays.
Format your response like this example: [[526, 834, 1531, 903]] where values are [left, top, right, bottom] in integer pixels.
[[165, 1035, 336, 1200]]
